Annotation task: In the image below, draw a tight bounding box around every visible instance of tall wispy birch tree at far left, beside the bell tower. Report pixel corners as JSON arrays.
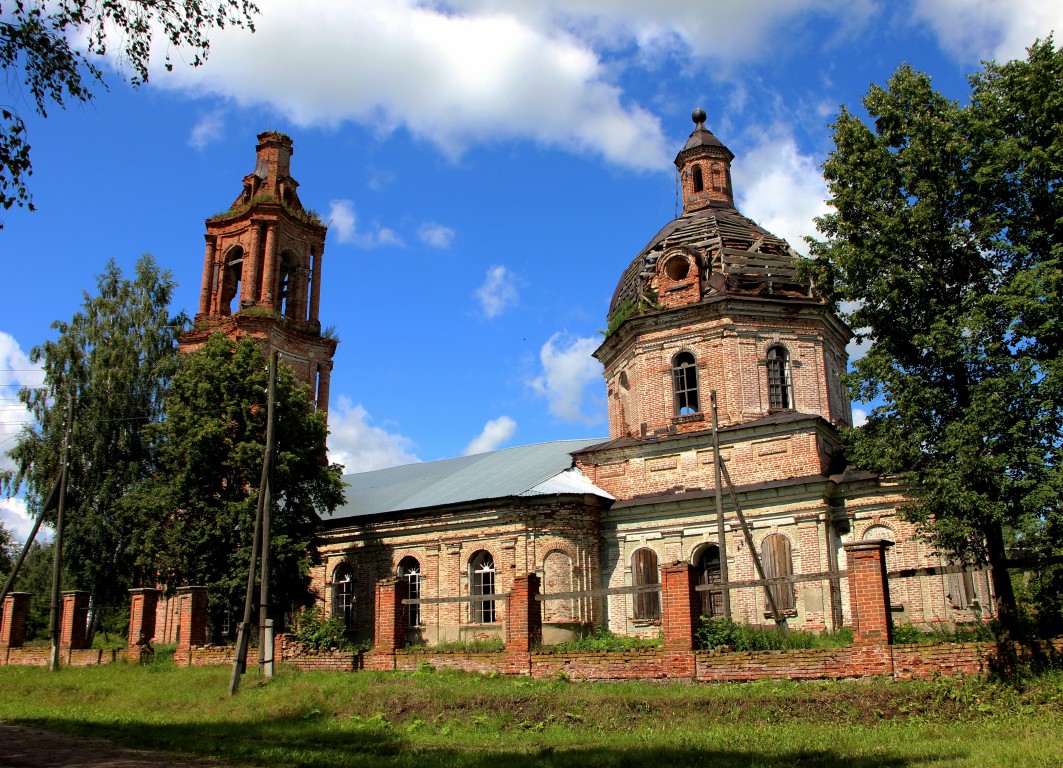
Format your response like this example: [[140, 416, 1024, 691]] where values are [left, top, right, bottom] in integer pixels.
[[0, 255, 186, 605]]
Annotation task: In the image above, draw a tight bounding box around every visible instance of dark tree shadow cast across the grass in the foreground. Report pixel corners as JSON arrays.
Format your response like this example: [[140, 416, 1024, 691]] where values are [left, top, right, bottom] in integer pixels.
[[2, 711, 965, 768]]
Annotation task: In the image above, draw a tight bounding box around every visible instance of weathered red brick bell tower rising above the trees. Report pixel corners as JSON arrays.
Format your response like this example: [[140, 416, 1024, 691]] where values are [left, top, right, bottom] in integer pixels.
[[181, 131, 338, 412]]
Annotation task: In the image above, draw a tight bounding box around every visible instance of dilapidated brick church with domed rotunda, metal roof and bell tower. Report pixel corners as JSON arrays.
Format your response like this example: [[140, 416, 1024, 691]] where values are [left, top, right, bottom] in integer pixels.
[[183, 110, 990, 645]]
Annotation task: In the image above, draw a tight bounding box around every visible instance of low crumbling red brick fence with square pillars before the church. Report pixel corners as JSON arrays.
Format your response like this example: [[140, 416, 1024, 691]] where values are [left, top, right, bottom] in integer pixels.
[[0, 541, 1063, 682]]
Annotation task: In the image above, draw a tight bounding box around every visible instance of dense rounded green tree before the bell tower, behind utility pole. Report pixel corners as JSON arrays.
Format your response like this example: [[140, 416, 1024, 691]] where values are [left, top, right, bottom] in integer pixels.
[[128, 334, 343, 625]]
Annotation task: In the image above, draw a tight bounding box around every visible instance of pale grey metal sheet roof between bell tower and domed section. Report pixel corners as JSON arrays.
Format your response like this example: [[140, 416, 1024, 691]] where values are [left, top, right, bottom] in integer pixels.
[[325, 437, 612, 524]]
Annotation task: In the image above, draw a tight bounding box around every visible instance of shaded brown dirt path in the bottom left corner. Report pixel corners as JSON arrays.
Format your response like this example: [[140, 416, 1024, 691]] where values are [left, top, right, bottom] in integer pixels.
[[0, 723, 237, 768]]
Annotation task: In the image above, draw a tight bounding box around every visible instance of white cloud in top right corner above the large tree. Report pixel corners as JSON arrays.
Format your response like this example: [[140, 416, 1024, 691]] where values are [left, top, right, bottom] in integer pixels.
[[912, 0, 1063, 62]]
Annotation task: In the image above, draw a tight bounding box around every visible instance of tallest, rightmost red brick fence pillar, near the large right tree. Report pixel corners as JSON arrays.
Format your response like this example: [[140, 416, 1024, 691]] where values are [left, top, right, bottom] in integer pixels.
[[845, 539, 893, 646]]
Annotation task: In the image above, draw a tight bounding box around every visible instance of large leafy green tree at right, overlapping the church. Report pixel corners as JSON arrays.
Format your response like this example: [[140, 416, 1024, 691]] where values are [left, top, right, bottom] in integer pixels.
[[813, 38, 1063, 633]]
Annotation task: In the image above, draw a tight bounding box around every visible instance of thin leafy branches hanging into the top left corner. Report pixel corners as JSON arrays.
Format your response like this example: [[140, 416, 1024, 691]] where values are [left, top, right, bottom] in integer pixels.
[[0, 0, 258, 228]]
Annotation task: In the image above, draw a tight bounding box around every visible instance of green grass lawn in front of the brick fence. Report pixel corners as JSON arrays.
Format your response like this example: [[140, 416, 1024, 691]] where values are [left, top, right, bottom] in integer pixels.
[[0, 662, 1063, 768]]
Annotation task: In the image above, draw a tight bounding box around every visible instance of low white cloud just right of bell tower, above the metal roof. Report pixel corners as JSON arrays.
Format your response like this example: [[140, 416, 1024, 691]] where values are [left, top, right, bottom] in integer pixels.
[[328, 396, 421, 472]]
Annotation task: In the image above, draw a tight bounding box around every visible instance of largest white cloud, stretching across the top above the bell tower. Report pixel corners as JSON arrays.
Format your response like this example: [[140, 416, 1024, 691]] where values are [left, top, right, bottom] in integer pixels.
[[151, 0, 671, 169]]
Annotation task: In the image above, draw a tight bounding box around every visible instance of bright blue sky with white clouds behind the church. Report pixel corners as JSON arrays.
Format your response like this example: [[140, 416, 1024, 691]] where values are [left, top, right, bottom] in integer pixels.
[[0, 0, 1063, 532]]
